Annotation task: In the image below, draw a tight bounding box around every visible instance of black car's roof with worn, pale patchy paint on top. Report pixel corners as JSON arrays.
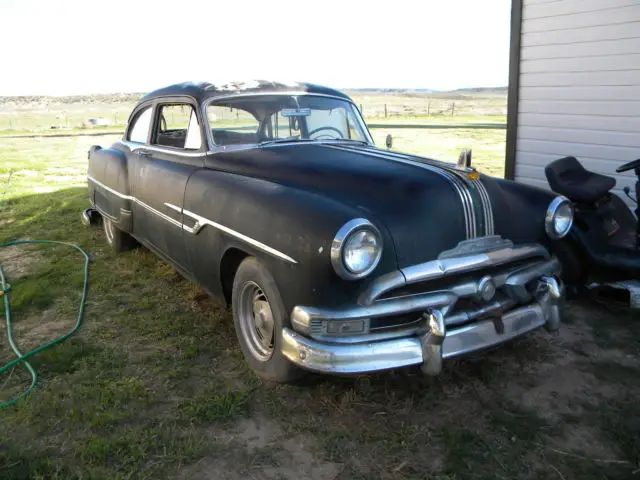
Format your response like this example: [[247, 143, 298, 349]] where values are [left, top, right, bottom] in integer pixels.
[[140, 80, 351, 103]]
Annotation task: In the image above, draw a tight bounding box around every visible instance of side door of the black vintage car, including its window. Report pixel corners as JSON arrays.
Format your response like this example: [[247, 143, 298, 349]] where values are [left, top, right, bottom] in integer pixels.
[[129, 99, 206, 276]]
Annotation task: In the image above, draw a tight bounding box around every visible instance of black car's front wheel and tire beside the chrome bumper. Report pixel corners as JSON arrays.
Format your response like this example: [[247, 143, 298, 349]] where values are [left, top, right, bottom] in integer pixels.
[[231, 257, 304, 383]]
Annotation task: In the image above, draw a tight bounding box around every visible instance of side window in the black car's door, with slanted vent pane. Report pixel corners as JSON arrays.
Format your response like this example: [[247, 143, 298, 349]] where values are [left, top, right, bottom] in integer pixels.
[[153, 104, 202, 149]]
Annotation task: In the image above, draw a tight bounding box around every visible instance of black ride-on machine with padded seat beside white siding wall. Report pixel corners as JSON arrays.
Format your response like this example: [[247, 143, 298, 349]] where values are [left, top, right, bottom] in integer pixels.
[[545, 157, 640, 309]]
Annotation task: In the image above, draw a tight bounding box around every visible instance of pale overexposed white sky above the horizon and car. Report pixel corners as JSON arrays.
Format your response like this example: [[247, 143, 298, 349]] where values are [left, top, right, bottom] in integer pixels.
[[0, 0, 511, 96]]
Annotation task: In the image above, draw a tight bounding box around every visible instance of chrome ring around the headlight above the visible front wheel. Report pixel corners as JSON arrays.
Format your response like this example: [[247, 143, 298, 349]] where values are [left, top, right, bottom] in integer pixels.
[[330, 218, 383, 280]]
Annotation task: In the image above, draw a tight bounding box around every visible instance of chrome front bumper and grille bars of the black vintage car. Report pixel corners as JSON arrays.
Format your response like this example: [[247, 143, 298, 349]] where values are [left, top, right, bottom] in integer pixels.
[[281, 240, 564, 375]]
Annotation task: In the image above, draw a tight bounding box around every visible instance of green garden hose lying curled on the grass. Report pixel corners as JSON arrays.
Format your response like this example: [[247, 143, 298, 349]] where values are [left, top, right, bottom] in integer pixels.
[[0, 240, 89, 408]]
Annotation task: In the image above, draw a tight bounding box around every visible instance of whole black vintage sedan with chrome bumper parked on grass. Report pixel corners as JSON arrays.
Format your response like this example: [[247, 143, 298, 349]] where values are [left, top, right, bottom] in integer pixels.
[[83, 81, 573, 381]]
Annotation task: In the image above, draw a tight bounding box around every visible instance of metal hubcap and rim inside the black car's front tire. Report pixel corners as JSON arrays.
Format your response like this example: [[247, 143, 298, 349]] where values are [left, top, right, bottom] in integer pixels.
[[238, 282, 275, 362]]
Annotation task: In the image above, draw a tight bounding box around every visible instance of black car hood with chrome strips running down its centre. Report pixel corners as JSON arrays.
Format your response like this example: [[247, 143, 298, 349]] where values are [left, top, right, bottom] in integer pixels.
[[210, 142, 552, 268]]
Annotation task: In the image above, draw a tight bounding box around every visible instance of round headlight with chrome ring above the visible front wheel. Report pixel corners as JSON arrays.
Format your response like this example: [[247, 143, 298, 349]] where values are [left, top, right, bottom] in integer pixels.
[[331, 218, 382, 280]]
